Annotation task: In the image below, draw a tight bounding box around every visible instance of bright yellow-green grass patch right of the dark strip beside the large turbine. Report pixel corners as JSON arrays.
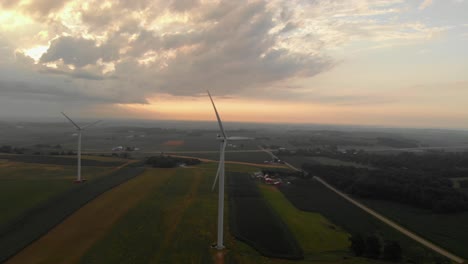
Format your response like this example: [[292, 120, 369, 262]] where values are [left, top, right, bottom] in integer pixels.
[[259, 184, 350, 259]]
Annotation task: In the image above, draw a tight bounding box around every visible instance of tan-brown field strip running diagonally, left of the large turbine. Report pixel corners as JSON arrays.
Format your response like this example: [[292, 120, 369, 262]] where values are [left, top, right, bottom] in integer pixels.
[[6, 169, 174, 264]]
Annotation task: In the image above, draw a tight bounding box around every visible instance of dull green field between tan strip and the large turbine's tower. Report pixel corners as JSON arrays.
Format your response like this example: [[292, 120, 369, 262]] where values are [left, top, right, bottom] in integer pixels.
[[81, 169, 215, 263]]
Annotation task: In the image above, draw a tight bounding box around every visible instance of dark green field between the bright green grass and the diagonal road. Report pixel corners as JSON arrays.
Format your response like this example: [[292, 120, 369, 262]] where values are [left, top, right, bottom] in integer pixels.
[[280, 180, 452, 263]]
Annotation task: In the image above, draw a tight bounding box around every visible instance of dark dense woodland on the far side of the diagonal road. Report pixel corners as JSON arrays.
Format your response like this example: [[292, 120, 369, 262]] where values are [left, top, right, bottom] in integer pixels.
[[303, 164, 468, 213]]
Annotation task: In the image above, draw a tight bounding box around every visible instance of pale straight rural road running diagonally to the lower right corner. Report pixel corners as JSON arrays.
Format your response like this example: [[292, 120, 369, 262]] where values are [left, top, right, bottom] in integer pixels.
[[259, 146, 465, 263]]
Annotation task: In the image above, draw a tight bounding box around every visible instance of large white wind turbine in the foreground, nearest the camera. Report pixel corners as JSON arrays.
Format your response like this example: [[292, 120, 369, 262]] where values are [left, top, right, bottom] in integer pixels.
[[207, 91, 251, 250]]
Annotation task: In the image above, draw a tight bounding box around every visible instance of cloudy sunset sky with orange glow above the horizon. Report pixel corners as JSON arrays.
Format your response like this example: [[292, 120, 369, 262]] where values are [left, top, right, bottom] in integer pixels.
[[0, 0, 468, 128]]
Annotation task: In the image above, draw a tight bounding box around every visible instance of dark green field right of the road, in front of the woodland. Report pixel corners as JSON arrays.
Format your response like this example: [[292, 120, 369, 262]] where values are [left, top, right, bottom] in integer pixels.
[[362, 200, 468, 258]]
